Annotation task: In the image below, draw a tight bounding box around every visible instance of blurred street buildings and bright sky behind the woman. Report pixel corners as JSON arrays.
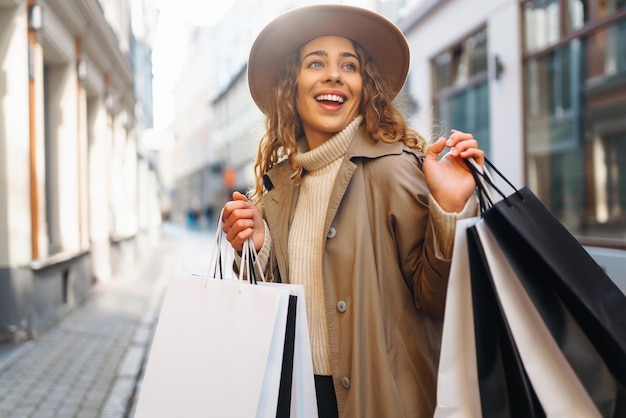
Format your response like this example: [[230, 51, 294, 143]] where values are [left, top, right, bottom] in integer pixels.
[[0, 0, 626, 350]]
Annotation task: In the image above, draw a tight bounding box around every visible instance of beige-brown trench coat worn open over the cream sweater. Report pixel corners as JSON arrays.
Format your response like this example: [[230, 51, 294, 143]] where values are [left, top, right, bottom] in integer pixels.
[[263, 128, 449, 418]]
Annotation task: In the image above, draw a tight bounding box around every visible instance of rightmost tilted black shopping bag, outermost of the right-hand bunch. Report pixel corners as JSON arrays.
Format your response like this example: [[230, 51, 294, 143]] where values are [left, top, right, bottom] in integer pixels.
[[483, 188, 626, 376]]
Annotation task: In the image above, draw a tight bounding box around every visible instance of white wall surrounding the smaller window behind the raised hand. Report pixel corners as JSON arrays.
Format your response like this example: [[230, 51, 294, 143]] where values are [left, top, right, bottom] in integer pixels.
[[400, 0, 524, 186]]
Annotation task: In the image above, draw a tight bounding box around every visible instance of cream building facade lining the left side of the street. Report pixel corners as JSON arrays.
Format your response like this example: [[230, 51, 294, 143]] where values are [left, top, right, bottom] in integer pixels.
[[0, 0, 159, 342]]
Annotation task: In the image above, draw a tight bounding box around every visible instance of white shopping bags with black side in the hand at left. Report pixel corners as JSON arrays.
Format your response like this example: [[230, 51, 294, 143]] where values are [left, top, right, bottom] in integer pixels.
[[135, 217, 317, 418]]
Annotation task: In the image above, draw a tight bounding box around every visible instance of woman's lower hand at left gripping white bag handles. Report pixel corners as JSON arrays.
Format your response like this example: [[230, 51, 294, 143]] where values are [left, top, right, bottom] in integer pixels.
[[222, 192, 265, 251]]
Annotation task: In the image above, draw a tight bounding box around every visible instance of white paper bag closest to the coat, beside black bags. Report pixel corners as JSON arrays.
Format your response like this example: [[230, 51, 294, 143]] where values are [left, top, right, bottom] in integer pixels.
[[435, 218, 482, 418]]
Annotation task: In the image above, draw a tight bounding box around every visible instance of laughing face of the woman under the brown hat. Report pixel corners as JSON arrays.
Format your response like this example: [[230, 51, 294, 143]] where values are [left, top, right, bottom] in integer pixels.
[[296, 36, 363, 149]]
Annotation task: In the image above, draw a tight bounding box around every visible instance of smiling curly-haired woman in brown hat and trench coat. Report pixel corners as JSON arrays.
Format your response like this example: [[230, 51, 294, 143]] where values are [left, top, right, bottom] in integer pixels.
[[223, 5, 483, 418]]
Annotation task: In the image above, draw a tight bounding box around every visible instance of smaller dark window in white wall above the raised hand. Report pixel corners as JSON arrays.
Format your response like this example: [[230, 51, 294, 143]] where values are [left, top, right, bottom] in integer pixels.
[[431, 29, 490, 155]]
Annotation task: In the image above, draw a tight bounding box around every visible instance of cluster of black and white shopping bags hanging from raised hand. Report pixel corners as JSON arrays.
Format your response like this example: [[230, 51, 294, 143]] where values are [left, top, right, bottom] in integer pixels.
[[435, 161, 626, 418]]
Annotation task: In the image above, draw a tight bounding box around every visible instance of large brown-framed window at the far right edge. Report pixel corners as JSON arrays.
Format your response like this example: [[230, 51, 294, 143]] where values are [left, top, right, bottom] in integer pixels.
[[522, 0, 626, 242]]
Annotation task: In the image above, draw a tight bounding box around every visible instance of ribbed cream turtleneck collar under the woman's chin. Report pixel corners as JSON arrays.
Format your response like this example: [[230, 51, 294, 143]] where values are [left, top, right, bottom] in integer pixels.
[[295, 115, 363, 171]]
